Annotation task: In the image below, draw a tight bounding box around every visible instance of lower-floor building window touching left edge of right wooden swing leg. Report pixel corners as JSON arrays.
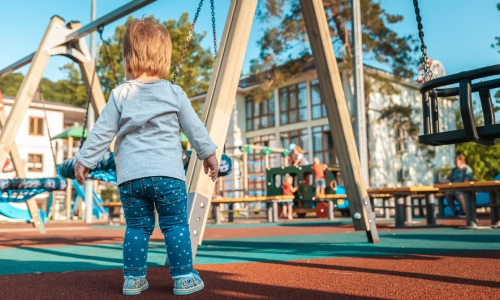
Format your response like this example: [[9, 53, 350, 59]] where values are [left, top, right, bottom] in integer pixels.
[[312, 126, 339, 165]]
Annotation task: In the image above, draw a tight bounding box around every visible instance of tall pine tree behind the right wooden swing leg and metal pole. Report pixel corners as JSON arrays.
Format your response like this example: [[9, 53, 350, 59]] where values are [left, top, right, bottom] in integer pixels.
[[251, 0, 418, 183]]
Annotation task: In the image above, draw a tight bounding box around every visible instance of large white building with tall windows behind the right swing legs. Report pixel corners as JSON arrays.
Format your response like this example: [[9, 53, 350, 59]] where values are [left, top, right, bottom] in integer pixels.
[[191, 62, 455, 190]]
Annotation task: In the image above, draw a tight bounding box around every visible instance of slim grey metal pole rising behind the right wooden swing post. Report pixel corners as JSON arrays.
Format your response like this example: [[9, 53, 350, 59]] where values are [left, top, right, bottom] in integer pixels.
[[351, 0, 369, 186]]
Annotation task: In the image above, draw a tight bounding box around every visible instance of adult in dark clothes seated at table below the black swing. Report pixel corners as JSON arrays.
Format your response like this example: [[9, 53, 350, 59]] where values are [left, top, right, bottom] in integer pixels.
[[443, 153, 474, 218]]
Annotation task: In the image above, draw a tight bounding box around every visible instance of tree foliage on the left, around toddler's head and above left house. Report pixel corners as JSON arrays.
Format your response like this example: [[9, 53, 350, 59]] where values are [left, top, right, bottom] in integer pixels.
[[0, 13, 215, 113]]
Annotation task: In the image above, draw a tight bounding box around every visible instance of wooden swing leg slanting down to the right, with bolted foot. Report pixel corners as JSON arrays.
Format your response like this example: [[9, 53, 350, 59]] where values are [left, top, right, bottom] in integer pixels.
[[300, 0, 379, 243]]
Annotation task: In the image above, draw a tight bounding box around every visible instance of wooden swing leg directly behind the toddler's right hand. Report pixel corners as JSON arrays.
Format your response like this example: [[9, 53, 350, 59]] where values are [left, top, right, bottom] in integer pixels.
[[186, 0, 257, 257]]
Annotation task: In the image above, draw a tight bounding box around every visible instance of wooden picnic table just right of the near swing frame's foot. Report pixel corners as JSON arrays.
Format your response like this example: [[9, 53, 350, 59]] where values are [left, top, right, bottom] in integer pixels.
[[368, 186, 442, 227]]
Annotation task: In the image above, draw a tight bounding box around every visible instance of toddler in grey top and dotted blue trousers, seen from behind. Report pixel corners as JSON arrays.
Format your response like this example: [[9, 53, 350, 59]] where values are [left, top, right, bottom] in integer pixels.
[[75, 18, 218, 295]]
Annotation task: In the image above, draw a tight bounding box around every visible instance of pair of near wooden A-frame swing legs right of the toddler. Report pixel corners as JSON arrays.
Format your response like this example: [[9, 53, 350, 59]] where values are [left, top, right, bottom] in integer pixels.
[[186, 0, 379, 257]]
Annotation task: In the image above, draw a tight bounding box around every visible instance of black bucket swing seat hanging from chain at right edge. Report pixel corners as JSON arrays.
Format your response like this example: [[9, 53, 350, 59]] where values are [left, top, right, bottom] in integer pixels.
[[418, 65, 500, 146]]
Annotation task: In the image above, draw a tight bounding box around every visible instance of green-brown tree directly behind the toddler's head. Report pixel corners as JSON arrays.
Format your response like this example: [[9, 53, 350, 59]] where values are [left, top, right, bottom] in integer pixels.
[[97, 13, 215, 105]]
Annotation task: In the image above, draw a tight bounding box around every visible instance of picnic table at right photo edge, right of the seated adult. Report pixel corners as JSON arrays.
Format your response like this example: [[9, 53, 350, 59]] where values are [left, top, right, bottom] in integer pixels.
[[434, 180, 500, 229]]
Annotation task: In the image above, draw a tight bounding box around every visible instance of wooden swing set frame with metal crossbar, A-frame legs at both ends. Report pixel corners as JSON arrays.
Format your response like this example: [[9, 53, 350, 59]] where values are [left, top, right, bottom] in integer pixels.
[[0, 0, 379, 257]]
